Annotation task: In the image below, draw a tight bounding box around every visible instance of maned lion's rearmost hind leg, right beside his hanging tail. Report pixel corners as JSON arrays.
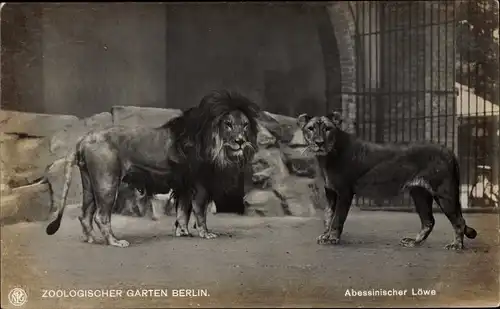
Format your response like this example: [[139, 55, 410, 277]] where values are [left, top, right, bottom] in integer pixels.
[[78, 166, 96, 243]]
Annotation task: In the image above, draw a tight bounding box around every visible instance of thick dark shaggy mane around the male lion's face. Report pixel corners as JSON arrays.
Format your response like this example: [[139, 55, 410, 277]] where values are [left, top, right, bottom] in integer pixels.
[[163, 90, 260, 199]]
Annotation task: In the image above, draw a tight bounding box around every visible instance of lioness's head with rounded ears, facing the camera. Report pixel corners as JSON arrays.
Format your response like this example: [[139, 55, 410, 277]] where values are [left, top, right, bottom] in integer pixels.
[[297, 112, 342, 155]]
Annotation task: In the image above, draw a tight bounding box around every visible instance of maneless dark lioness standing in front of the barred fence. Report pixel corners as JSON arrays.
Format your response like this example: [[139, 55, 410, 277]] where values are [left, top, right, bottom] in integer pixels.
[[298, 112, 477, 250]]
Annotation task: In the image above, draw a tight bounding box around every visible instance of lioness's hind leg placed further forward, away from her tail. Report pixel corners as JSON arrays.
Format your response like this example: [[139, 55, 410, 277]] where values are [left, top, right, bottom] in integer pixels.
[[401, 187, 435, 247]]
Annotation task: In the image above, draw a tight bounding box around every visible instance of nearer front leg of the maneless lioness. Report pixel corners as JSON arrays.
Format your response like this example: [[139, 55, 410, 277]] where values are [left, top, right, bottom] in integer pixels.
[[318, 191, 353, 245]]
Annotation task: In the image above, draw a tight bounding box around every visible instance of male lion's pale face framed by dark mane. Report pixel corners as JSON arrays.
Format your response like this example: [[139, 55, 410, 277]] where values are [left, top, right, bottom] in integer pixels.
[[218, 111, 255, 163]]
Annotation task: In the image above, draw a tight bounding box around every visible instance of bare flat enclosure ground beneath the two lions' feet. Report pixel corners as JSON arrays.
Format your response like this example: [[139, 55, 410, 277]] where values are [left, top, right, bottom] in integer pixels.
[[2, 209, 499, 308]]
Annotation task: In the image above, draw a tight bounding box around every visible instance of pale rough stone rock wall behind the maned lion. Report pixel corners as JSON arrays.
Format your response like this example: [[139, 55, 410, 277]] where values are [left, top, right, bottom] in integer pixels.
[[0, 106, 324, 223]]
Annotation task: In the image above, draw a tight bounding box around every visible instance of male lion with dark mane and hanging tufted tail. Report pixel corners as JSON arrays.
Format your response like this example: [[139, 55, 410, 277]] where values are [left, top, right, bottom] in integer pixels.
[[46, 91, 259, 247]]
